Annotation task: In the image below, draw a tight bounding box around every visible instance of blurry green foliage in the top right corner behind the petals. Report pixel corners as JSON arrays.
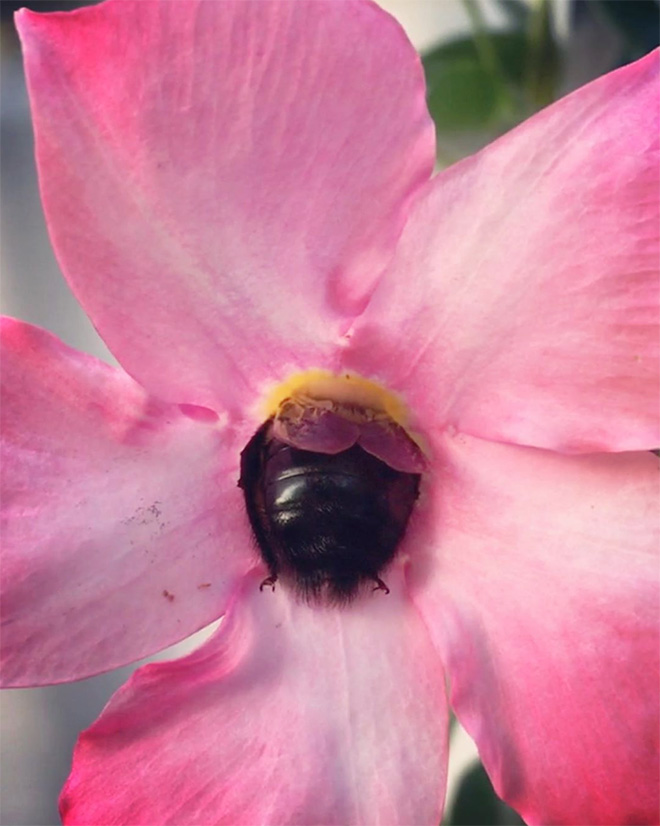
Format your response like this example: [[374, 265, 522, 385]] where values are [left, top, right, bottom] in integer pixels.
[[422, 0, 660, 165]]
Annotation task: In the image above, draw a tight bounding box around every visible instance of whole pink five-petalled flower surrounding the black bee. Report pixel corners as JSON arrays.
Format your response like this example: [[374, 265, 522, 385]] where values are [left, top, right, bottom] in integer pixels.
[[2, 0, 660, 824]]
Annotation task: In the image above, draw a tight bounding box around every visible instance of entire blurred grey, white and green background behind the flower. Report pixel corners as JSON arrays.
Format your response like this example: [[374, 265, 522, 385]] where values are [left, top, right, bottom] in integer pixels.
[[0, 0, 660, 826]]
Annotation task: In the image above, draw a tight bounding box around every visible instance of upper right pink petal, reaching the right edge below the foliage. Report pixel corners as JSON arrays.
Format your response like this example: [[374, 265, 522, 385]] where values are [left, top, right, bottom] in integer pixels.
[[345, 52, 660, 452]]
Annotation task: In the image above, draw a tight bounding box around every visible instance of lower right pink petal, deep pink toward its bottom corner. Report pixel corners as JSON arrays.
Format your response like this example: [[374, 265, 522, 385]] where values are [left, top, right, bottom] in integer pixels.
[[413, 436, 660, 824]]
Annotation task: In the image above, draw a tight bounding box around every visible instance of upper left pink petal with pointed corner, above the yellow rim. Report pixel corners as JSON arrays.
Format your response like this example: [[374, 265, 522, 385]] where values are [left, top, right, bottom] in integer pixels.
[[18, 0, 434, 413]]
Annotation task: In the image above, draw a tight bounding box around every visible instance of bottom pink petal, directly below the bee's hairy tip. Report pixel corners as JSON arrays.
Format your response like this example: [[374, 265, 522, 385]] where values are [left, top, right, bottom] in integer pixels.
[[60, 569, 447, 826]]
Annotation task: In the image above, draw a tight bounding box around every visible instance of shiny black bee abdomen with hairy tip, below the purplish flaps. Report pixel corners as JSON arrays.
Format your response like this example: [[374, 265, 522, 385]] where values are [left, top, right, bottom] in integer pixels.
[[239, 418, 420, 603]]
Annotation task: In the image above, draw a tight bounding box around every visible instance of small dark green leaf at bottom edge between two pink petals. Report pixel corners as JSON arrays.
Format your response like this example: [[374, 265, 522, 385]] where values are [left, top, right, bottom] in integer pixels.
[[445, 763, 524, 826]]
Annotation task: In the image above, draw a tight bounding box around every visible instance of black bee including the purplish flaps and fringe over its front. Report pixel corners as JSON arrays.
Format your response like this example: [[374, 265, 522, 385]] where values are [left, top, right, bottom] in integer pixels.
[[240, 376, 422, 604]]
